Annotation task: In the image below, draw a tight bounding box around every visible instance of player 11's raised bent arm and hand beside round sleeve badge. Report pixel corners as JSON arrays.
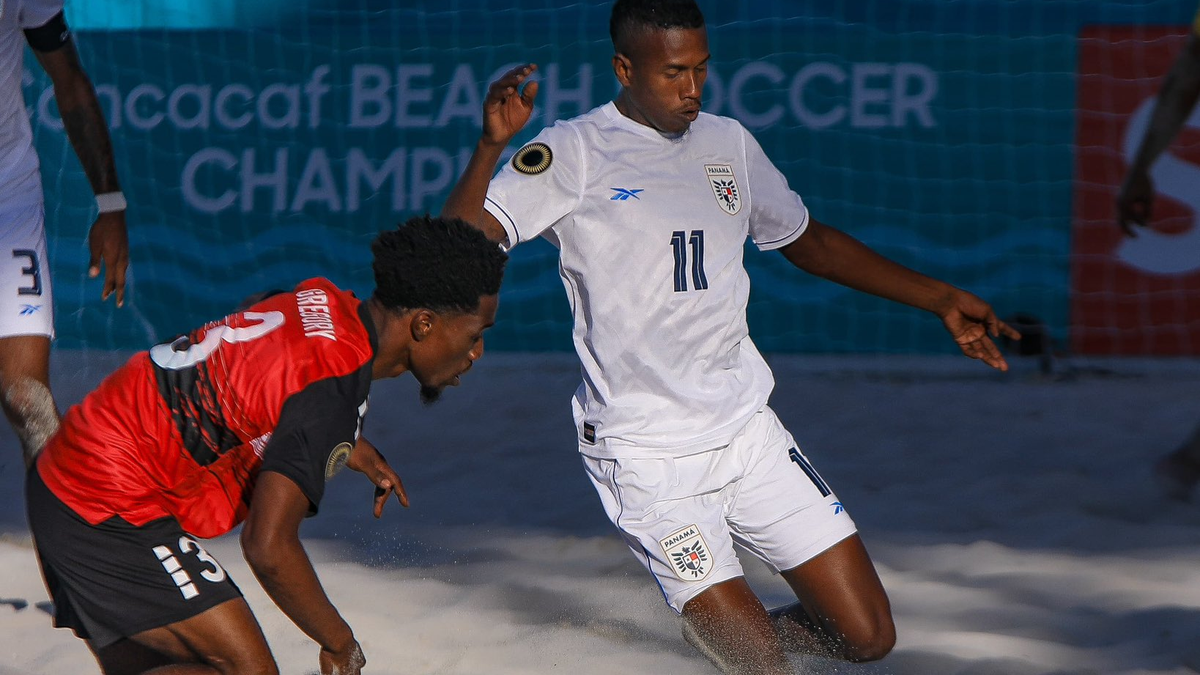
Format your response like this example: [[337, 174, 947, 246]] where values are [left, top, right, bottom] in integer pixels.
[[442, 64, 538, 244]]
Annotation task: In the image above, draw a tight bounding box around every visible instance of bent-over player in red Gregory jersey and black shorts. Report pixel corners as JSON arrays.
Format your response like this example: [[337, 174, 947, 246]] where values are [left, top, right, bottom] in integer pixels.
[[26, 217, 506, 675]]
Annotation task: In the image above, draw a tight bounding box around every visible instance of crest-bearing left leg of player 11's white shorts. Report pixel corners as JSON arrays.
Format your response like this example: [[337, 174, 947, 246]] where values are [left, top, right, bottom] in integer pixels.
[[583, 452, 742, 611]]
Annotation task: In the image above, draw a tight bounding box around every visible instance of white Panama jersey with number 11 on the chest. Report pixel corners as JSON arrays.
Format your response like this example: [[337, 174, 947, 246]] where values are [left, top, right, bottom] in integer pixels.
[[485, 103, 809, 458]]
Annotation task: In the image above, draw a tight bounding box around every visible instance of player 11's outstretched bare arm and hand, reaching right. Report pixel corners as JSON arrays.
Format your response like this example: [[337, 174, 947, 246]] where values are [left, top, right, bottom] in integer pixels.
[[780, 219, 1021, 370]]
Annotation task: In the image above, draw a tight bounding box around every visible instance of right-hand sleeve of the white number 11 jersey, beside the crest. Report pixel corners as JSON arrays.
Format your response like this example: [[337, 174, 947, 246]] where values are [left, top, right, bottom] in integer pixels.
[[742, 127, 809, 251]]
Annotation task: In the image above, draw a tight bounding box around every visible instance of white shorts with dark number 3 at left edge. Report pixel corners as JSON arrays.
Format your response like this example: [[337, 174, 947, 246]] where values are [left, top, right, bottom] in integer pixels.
[[0, 203, 54, 338]]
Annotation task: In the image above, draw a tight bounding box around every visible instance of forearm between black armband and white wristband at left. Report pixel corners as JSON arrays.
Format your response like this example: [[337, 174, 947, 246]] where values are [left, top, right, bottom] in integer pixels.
[[54, 78, 121, 195]]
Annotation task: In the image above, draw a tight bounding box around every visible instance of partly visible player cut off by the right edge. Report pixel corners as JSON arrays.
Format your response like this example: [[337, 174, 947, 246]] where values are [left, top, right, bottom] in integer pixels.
[[1117, 2, 1200, 500]]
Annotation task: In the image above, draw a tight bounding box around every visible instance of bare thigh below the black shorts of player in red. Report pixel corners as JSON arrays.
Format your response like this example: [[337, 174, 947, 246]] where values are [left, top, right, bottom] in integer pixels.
[[131, 598, 278, 675]]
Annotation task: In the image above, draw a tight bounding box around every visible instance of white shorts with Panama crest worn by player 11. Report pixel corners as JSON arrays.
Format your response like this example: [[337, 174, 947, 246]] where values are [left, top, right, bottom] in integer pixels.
[[583, 406, 857, 613]]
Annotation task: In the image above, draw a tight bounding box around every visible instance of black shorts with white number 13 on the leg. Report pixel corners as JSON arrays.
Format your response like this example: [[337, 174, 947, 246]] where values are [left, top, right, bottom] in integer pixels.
[[25, 467, 241, 647]]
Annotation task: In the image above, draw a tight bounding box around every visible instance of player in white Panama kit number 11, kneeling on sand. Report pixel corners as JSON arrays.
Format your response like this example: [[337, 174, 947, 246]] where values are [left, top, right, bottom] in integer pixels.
[[445, 0, 1016, 673]]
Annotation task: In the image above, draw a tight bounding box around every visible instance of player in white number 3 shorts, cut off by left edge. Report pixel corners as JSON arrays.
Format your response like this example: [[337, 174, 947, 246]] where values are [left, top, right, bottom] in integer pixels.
[[0, 0, 128, 465]]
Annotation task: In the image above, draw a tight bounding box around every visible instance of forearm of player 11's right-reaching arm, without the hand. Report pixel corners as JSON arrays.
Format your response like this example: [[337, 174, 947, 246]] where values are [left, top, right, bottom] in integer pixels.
[[782, 220, 956, 313]]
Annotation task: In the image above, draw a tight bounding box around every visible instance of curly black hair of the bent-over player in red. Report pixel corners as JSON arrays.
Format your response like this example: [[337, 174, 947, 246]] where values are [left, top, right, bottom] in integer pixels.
[[371, 215, 509, 312]]
